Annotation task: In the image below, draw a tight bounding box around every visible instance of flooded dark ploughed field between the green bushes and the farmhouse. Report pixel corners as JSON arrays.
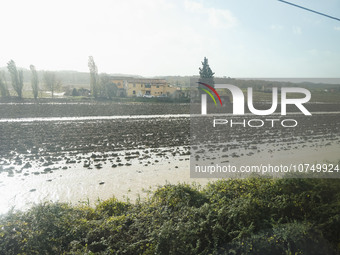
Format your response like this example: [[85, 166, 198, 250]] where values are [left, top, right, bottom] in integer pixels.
[[0, 102, 340, 213]]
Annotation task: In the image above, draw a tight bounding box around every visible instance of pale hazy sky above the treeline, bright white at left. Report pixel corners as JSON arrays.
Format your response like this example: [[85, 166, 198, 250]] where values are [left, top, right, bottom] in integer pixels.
[[0, 0, 340, 77]]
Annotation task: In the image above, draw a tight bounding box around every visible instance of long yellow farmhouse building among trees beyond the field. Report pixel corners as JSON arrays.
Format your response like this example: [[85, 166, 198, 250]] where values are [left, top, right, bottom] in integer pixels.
[[111, 77, 177, 97]]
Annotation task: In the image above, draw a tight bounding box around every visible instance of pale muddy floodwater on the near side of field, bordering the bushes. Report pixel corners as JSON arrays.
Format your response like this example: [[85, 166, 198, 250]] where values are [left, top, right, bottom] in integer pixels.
[[0, 142, 340, 213]]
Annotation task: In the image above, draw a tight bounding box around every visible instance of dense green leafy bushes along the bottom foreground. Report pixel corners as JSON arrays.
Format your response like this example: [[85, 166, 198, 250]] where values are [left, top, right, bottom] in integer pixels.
[[0, 178, 340, 254]]
